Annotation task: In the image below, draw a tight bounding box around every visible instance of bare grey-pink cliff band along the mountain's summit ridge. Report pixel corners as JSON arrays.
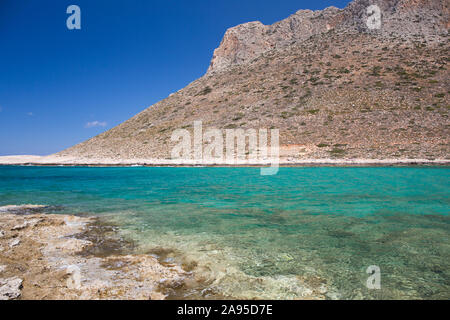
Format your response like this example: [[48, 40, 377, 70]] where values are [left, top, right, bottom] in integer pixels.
[[208, 0, 449, 73]]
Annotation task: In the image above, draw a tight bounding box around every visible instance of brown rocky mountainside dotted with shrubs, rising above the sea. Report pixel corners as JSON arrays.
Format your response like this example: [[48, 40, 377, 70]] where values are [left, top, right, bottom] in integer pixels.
[[57, 0, 450, 159]]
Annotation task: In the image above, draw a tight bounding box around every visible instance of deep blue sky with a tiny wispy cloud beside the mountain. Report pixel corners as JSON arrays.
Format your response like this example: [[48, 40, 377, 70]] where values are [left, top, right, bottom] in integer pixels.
[[0, 0, 349, 155]]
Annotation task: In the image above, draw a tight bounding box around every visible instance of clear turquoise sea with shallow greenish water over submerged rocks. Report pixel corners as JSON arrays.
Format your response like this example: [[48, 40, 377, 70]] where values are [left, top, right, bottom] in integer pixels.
[[0, 167, 450, 299]]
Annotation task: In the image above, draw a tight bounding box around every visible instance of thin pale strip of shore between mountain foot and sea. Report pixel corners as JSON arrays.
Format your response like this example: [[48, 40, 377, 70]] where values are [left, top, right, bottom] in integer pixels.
[[0, 155, 450, 166]]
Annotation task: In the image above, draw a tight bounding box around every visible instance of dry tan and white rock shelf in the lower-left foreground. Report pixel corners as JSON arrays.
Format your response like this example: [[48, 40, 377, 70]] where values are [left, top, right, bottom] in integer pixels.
[[0, 205, 190, 300]]
